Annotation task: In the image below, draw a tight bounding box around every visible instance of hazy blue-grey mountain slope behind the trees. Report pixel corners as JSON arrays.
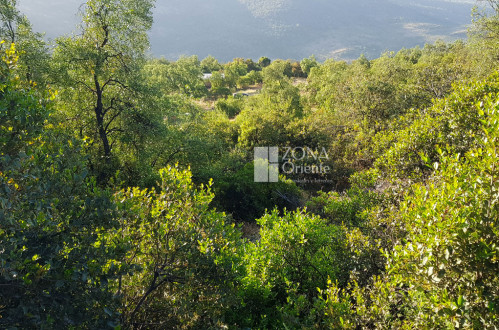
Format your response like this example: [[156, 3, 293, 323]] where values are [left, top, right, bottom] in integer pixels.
[[21, 0, 474, 60]]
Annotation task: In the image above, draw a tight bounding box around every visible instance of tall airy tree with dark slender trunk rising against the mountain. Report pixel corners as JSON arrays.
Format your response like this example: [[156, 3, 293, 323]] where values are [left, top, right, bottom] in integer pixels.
[[53, 0, 154, 179]]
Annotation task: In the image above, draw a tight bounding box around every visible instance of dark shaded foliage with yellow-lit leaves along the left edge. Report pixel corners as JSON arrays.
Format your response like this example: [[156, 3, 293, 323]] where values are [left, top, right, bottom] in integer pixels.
[[0, 43, 121, 328]]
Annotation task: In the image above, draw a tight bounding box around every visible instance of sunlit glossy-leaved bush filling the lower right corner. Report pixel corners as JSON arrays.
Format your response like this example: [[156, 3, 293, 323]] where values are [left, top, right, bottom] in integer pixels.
[[388, 114, 499, 328]]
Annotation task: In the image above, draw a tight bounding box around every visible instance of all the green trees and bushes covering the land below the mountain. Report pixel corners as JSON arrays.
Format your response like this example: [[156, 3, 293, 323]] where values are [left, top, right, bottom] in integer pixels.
[[0, 0, 499, 329]]
